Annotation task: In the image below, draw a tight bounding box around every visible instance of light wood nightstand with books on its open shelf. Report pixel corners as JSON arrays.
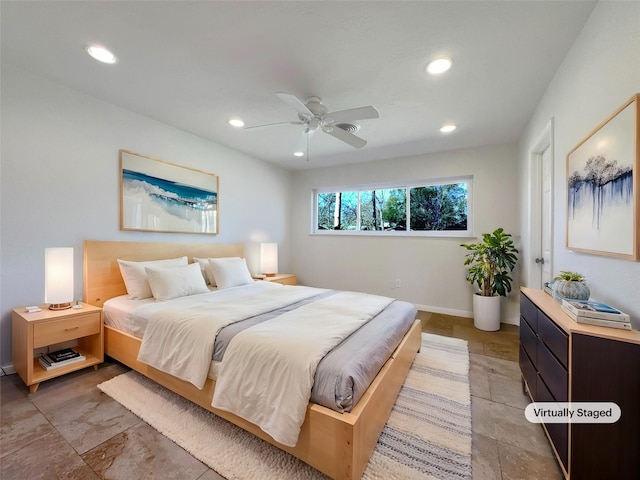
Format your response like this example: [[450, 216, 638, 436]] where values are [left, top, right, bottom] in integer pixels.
[[11, 303, 104, 393]]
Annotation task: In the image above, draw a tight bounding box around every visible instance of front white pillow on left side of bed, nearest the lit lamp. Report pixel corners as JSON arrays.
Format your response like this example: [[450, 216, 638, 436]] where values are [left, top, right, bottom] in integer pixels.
[[144, 263, 209, 302]]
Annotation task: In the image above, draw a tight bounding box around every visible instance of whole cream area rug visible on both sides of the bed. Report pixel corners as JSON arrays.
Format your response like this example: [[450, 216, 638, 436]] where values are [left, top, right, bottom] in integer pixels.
[[98, 333, 471, 480]]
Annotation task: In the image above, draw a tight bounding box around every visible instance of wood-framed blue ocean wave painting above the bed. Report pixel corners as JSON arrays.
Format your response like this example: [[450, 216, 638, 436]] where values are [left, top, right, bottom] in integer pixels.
[[120, 150, 218, 234]]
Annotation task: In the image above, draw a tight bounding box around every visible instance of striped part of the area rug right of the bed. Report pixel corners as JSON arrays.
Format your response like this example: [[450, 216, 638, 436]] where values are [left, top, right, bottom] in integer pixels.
[[363, 333, 471, 480]]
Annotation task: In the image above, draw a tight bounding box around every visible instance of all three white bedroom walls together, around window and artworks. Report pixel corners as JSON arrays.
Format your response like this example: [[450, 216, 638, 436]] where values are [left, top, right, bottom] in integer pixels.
[[0, 2, 640, 372]]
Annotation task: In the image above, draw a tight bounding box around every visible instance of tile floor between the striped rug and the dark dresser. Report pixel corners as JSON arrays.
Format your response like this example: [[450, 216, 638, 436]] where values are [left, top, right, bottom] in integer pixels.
[[418, 312, 563, 480]]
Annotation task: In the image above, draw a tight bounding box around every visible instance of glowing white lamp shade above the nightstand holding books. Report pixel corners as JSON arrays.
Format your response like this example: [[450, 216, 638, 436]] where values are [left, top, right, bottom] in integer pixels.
[[44, 247, 73, 305]]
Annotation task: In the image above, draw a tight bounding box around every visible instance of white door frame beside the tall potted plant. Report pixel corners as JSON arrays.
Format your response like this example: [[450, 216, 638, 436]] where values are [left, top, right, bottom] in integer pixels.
[[523, 117, 555, 288]]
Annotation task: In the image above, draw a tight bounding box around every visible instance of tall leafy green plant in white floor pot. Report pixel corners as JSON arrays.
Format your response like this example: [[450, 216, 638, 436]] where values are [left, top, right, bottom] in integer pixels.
[[460, 228, 518, 331]]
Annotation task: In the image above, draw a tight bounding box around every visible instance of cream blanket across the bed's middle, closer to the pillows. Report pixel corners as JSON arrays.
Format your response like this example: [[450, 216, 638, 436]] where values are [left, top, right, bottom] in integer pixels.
[[137, 282, 326, 389]]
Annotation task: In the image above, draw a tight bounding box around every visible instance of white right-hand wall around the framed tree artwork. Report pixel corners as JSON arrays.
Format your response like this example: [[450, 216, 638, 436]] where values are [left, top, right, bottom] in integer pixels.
[[519, 2, 640, 328]]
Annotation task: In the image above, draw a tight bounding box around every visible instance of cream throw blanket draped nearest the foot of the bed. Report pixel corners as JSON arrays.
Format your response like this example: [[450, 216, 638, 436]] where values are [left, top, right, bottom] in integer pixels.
[[212, 292, 393, 447]]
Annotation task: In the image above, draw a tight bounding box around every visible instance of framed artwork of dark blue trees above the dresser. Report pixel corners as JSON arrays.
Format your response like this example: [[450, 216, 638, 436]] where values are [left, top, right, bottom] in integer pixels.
[[566, 94, 640, 260]]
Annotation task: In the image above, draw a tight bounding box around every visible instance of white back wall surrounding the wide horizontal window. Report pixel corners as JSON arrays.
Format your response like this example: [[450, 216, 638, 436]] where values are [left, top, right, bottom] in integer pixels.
[[291, 145, 520, 323]]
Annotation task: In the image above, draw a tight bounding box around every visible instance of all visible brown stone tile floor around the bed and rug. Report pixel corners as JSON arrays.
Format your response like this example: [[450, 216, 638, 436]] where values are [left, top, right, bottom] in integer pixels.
[[0, 312, 562, 480]]
